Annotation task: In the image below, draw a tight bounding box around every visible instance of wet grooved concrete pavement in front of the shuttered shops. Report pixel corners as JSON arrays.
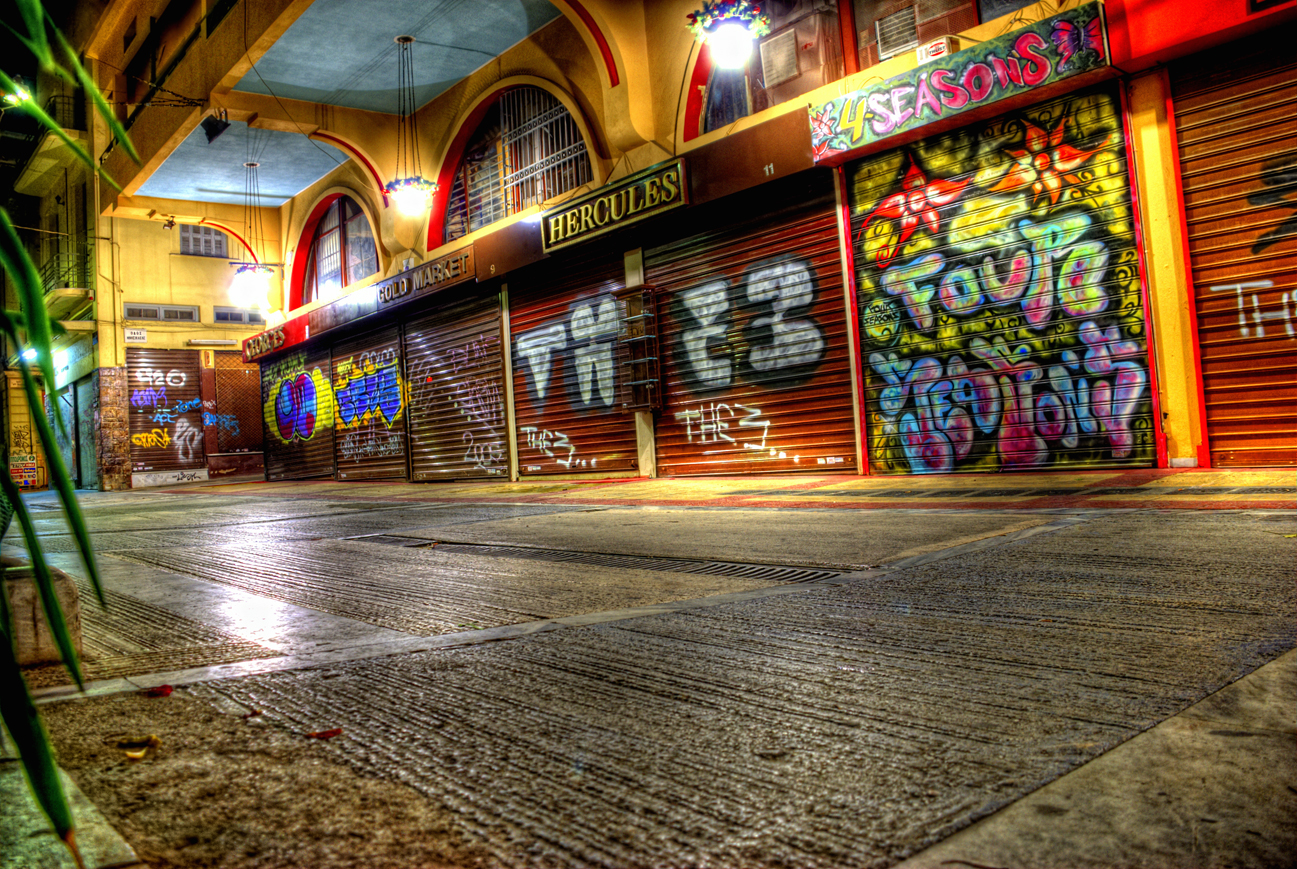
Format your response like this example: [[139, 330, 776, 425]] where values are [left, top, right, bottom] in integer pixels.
[[6, 472, 1297, 866]]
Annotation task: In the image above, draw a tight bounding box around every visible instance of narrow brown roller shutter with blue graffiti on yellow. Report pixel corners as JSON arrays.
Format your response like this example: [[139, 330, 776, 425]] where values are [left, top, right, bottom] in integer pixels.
[[333, 327, 406, 480]]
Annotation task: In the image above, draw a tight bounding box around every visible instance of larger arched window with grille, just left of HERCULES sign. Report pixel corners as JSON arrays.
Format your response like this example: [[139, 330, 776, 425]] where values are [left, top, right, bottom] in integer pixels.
[[445, 87, 593, 241]]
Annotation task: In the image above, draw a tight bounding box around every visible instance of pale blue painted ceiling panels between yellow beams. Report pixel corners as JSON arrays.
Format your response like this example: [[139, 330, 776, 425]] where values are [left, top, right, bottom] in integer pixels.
[[139, 0, 560, 206]]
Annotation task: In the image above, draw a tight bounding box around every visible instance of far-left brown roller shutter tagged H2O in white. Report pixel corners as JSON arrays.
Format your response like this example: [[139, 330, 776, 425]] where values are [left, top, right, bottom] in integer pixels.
[[126, 348, 208, 472]]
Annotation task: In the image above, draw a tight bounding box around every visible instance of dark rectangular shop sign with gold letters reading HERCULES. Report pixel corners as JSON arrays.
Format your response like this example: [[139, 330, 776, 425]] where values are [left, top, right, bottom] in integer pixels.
[[541, 158, 689, 253]]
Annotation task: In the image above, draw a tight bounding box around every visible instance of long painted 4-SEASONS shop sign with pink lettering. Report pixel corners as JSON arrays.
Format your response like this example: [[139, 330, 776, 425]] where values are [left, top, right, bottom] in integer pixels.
[[811, 3, 1109, 162]]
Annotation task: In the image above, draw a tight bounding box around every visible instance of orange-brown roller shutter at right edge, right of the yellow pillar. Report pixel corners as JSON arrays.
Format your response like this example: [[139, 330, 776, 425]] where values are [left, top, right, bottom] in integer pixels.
[[1171, 34, 1297, 467]]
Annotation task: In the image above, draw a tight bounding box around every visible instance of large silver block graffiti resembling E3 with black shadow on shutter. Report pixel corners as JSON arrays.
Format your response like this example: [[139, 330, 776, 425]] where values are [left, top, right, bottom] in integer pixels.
[[672, 256, 827, 393]]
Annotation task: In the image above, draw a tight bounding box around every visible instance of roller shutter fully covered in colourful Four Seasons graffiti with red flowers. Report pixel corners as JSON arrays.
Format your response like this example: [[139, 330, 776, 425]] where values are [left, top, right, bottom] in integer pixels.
[[847, 88, 1157, 473]]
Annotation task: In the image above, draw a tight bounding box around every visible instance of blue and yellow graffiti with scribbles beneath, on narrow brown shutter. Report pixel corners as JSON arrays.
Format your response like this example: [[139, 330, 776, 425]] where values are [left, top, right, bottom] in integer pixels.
[[333, 349, 405, 462]]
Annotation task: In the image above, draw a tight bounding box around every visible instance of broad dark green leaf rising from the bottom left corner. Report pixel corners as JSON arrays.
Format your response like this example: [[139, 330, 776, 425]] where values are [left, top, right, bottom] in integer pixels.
[[0, 607, 83, 866]]
